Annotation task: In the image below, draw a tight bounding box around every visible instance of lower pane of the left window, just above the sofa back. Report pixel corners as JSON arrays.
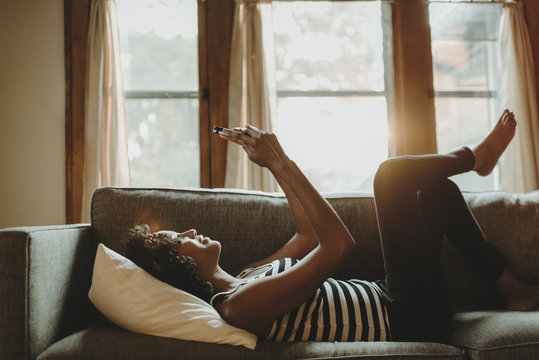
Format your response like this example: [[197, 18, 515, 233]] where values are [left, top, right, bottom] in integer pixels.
[[126, 99, 200, 187]]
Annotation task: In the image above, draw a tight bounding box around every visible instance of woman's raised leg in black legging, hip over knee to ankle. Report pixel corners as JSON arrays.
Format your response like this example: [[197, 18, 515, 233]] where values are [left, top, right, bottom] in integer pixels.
[[374, 148, 474, 342]]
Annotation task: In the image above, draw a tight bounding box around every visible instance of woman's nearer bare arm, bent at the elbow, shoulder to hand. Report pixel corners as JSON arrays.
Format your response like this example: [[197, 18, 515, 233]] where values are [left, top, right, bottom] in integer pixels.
[[218, 128, 355, 335]]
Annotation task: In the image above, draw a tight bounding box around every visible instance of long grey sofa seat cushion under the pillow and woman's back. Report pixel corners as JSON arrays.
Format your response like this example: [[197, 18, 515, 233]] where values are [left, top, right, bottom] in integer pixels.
[[38, 325, 466, 360]]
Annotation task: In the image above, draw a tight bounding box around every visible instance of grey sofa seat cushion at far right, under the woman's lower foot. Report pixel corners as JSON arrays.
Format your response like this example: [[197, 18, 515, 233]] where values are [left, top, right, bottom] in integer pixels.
[[452, 310, 539, 360]]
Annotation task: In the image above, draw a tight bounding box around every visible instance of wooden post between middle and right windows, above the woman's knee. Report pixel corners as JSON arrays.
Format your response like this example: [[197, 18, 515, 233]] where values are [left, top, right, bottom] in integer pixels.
[[390, 0, 436, 155]]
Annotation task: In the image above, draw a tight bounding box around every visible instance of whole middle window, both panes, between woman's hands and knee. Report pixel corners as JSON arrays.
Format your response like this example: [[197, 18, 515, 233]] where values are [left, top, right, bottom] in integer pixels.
[[273, 1, 391, 191]]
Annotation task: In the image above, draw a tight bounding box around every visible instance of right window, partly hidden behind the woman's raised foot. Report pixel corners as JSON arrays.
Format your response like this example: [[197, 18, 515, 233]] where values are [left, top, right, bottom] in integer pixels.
[[429, 3, 501, 191]]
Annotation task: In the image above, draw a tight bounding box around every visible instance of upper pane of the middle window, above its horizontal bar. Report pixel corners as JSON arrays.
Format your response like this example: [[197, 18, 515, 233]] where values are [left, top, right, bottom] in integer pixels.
[[273, 1, 384, 91]]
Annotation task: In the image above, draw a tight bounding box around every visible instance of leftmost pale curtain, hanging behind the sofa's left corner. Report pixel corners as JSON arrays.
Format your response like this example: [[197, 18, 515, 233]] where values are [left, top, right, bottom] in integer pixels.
[[81, 0, 129, 222]]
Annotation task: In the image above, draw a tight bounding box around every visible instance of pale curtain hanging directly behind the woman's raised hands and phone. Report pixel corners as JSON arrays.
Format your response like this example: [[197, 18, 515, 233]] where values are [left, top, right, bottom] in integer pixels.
[[225, 0, 278, 192]]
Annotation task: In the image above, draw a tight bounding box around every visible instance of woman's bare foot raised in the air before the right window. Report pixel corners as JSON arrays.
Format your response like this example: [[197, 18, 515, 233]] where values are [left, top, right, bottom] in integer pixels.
[[472, 109, 517, 176]]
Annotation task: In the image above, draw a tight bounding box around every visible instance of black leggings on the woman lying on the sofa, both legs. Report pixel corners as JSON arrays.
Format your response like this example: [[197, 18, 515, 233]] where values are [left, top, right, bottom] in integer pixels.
[[374, 148, 506, 342]]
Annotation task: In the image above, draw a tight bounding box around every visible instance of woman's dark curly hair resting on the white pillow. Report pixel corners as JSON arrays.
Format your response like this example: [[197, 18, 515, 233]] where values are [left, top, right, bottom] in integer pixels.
[[126, 225, 215, 302]]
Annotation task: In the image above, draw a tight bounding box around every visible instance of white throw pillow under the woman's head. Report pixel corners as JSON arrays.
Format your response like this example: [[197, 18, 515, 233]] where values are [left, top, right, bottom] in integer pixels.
[[88, 244, 257, 350]]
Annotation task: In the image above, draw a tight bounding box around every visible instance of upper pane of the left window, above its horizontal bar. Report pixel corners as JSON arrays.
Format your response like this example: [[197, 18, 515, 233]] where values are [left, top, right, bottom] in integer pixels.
[[116, 0, 198, 91]]
